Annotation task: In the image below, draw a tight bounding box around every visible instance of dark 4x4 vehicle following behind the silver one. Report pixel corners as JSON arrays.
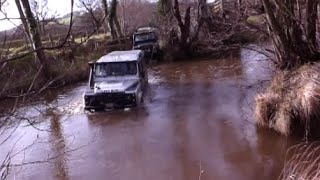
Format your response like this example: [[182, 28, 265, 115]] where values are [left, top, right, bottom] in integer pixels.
[[133, 27, 160, 58]]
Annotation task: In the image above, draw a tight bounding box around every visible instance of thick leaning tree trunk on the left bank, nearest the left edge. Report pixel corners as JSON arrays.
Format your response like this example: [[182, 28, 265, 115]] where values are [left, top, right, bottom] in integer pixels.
[[21, 0, 49, 78]]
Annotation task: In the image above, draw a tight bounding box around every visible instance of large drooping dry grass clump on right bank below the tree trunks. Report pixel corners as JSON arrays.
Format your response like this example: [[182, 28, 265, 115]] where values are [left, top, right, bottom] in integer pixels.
[[255, 63, 320, 137]]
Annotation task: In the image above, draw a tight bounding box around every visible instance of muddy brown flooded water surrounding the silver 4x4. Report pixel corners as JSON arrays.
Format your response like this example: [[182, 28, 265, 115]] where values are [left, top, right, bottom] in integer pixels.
[[0, 45, 300, 180]]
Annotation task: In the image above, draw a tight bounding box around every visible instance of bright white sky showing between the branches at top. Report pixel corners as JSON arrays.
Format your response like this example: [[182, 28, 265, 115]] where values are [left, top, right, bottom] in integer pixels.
[[0, 0, 215, 31]]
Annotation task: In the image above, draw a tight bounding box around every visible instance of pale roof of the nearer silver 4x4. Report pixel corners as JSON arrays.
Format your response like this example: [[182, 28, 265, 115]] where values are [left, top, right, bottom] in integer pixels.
[[97, 50, 143, 63]]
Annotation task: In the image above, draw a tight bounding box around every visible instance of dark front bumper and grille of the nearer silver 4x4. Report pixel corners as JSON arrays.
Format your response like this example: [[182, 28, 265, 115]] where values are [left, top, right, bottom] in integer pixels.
[[84, 93, 137, 110]]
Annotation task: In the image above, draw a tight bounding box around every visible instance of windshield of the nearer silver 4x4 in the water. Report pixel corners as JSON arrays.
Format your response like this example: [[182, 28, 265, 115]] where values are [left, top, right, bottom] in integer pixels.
[[95, 62, 137, 77]]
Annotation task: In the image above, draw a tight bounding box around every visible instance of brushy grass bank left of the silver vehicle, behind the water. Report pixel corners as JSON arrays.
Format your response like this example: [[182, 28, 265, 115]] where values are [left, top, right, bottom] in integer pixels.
[[0, 36, 131, 98]]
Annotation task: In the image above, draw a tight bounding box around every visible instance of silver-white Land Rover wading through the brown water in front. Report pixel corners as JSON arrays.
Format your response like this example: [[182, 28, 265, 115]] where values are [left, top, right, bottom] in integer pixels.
[[84, 50, 148, 110]]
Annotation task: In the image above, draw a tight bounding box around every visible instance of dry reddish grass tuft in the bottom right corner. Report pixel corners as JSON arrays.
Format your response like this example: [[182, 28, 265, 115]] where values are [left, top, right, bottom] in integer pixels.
[[279, 142, 320, 180]]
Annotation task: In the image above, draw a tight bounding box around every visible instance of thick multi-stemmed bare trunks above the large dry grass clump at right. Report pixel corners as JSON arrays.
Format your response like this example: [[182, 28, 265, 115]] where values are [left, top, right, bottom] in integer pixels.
[[262, 0, 320, 69]]
